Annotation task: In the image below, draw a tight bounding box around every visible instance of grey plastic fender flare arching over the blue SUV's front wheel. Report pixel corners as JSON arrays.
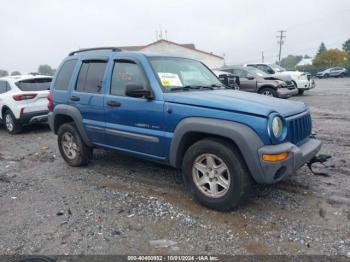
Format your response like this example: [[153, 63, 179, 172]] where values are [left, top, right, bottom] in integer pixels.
[[169, 117, 264, 181]]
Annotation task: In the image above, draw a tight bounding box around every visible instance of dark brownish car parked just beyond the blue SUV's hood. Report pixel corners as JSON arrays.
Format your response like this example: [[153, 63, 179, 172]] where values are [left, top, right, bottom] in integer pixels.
[[216, 66, 298, 98]]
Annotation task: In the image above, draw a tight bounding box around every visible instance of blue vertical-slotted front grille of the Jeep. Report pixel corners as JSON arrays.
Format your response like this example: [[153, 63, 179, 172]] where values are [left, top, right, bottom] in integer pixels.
[[287, 112, 312, 145]]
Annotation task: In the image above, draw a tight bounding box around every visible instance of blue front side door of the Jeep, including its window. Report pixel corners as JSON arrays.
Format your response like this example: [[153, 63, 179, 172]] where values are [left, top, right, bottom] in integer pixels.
[[104, 59, 165, 160]]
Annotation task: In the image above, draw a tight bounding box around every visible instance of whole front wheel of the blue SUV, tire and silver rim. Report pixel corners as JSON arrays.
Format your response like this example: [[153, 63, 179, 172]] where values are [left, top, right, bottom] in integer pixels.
[[182, 138, 251, 211]]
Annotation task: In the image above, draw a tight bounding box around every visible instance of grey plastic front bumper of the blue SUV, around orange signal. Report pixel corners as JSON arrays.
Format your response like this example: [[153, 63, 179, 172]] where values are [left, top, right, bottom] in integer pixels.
[[258, 138, 321, 184]]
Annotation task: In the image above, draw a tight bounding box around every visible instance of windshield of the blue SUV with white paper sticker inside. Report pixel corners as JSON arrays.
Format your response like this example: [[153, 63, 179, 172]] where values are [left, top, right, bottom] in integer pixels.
[[150, 57, 223, 92]]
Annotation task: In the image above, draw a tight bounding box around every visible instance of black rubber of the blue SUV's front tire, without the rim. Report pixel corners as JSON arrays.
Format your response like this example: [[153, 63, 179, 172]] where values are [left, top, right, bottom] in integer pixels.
[[183, 139, 250, 211]]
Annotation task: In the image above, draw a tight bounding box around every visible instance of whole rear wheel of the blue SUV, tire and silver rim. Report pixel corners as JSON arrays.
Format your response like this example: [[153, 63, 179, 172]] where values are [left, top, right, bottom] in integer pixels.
[[57, 123, 92, 167]]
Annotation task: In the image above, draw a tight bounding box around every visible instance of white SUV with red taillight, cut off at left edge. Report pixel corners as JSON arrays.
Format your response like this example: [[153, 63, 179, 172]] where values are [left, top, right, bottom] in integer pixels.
[[0, 75, 52, 134]]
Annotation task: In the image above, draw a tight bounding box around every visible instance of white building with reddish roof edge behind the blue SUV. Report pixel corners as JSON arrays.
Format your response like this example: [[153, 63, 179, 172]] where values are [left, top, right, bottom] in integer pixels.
[[119, 39, 224, 68]]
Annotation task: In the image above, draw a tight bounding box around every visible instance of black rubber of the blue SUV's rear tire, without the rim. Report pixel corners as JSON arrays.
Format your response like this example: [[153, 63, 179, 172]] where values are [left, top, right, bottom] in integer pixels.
[[57, 123, 89, 166]]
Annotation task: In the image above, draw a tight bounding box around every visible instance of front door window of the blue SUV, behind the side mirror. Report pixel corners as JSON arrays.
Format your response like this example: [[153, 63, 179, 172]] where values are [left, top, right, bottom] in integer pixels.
[[110, 60, 147, 96]]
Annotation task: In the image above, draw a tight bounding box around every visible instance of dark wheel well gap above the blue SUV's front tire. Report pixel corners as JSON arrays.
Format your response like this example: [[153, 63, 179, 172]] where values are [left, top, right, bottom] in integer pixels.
[[176, 132, 247, 168]]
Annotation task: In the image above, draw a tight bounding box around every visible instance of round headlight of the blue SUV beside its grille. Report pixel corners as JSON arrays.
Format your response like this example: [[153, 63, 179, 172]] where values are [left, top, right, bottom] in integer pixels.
[[268, 113, 288, 144]]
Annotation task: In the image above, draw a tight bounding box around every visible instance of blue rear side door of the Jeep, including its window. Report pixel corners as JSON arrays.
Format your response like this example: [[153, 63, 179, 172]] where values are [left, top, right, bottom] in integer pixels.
[[69, 58, 108, 144]]
